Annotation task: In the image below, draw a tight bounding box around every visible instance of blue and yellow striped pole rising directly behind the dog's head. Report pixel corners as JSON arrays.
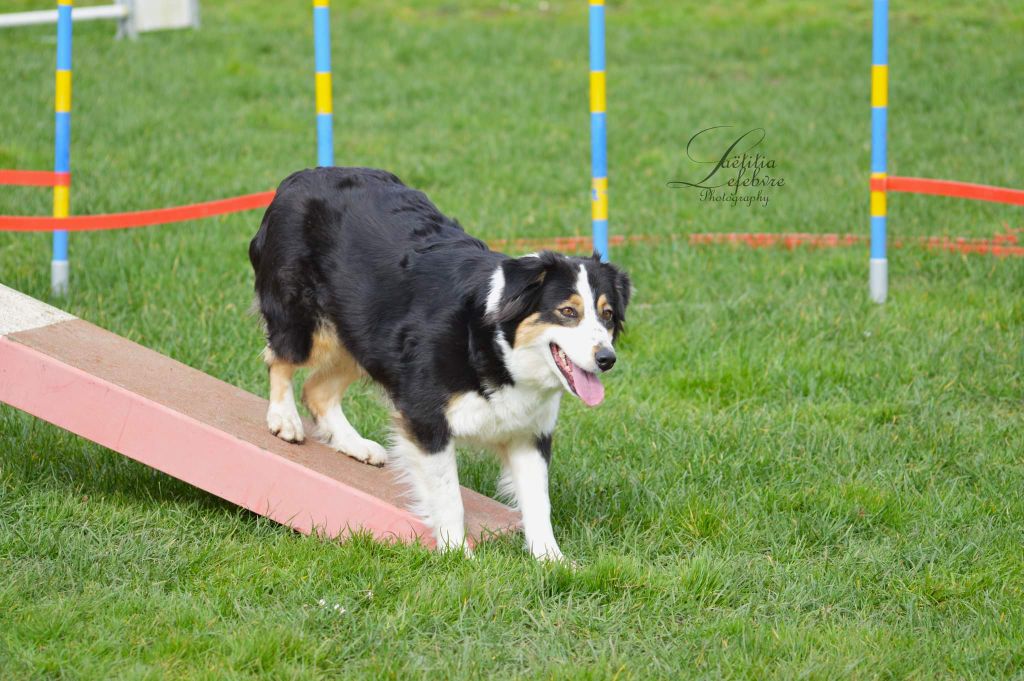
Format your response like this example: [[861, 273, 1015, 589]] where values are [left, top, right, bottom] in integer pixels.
[[590, 0, 608, 261]]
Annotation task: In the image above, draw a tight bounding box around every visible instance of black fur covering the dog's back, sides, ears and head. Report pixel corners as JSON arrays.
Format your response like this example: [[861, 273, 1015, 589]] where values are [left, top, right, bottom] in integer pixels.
[[249, 168, 630, 456]]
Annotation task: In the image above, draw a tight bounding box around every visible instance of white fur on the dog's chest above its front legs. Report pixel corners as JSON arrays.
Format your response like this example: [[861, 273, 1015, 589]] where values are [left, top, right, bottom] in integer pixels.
[[445, 383, 561, 446]]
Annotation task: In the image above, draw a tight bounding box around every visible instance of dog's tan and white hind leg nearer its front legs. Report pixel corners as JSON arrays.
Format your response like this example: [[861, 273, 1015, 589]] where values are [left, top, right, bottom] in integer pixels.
[[302, 331, 387, 466]]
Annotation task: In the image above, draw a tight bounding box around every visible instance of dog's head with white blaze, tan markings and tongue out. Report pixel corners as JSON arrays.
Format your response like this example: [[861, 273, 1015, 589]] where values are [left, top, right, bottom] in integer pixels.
[[487, 251, 632, 407]]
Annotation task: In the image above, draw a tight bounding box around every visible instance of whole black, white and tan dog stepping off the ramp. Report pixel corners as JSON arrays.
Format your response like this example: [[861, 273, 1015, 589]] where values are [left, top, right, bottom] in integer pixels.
[[249, 168, 631, 559]]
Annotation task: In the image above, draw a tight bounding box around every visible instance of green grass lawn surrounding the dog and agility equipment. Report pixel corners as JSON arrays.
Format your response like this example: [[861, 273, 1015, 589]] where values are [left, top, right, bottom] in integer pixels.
[[0, 0, 1024, 679]]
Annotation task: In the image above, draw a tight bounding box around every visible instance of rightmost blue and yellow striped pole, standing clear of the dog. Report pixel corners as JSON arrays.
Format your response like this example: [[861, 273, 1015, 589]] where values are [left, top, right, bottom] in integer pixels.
[[868, 0, 889, 303]]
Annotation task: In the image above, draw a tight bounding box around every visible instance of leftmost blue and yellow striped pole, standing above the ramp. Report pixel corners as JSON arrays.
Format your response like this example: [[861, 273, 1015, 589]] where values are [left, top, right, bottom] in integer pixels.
[[50, 0, 72, 295]]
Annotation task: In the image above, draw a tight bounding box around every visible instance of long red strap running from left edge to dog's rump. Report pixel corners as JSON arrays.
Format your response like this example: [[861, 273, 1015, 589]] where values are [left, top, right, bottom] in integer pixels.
[[0, 191, 274, 231]]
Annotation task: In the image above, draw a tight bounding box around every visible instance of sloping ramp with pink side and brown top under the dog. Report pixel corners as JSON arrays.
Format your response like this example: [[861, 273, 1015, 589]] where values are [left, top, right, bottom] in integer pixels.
[[0, 285, 519, 547]]
